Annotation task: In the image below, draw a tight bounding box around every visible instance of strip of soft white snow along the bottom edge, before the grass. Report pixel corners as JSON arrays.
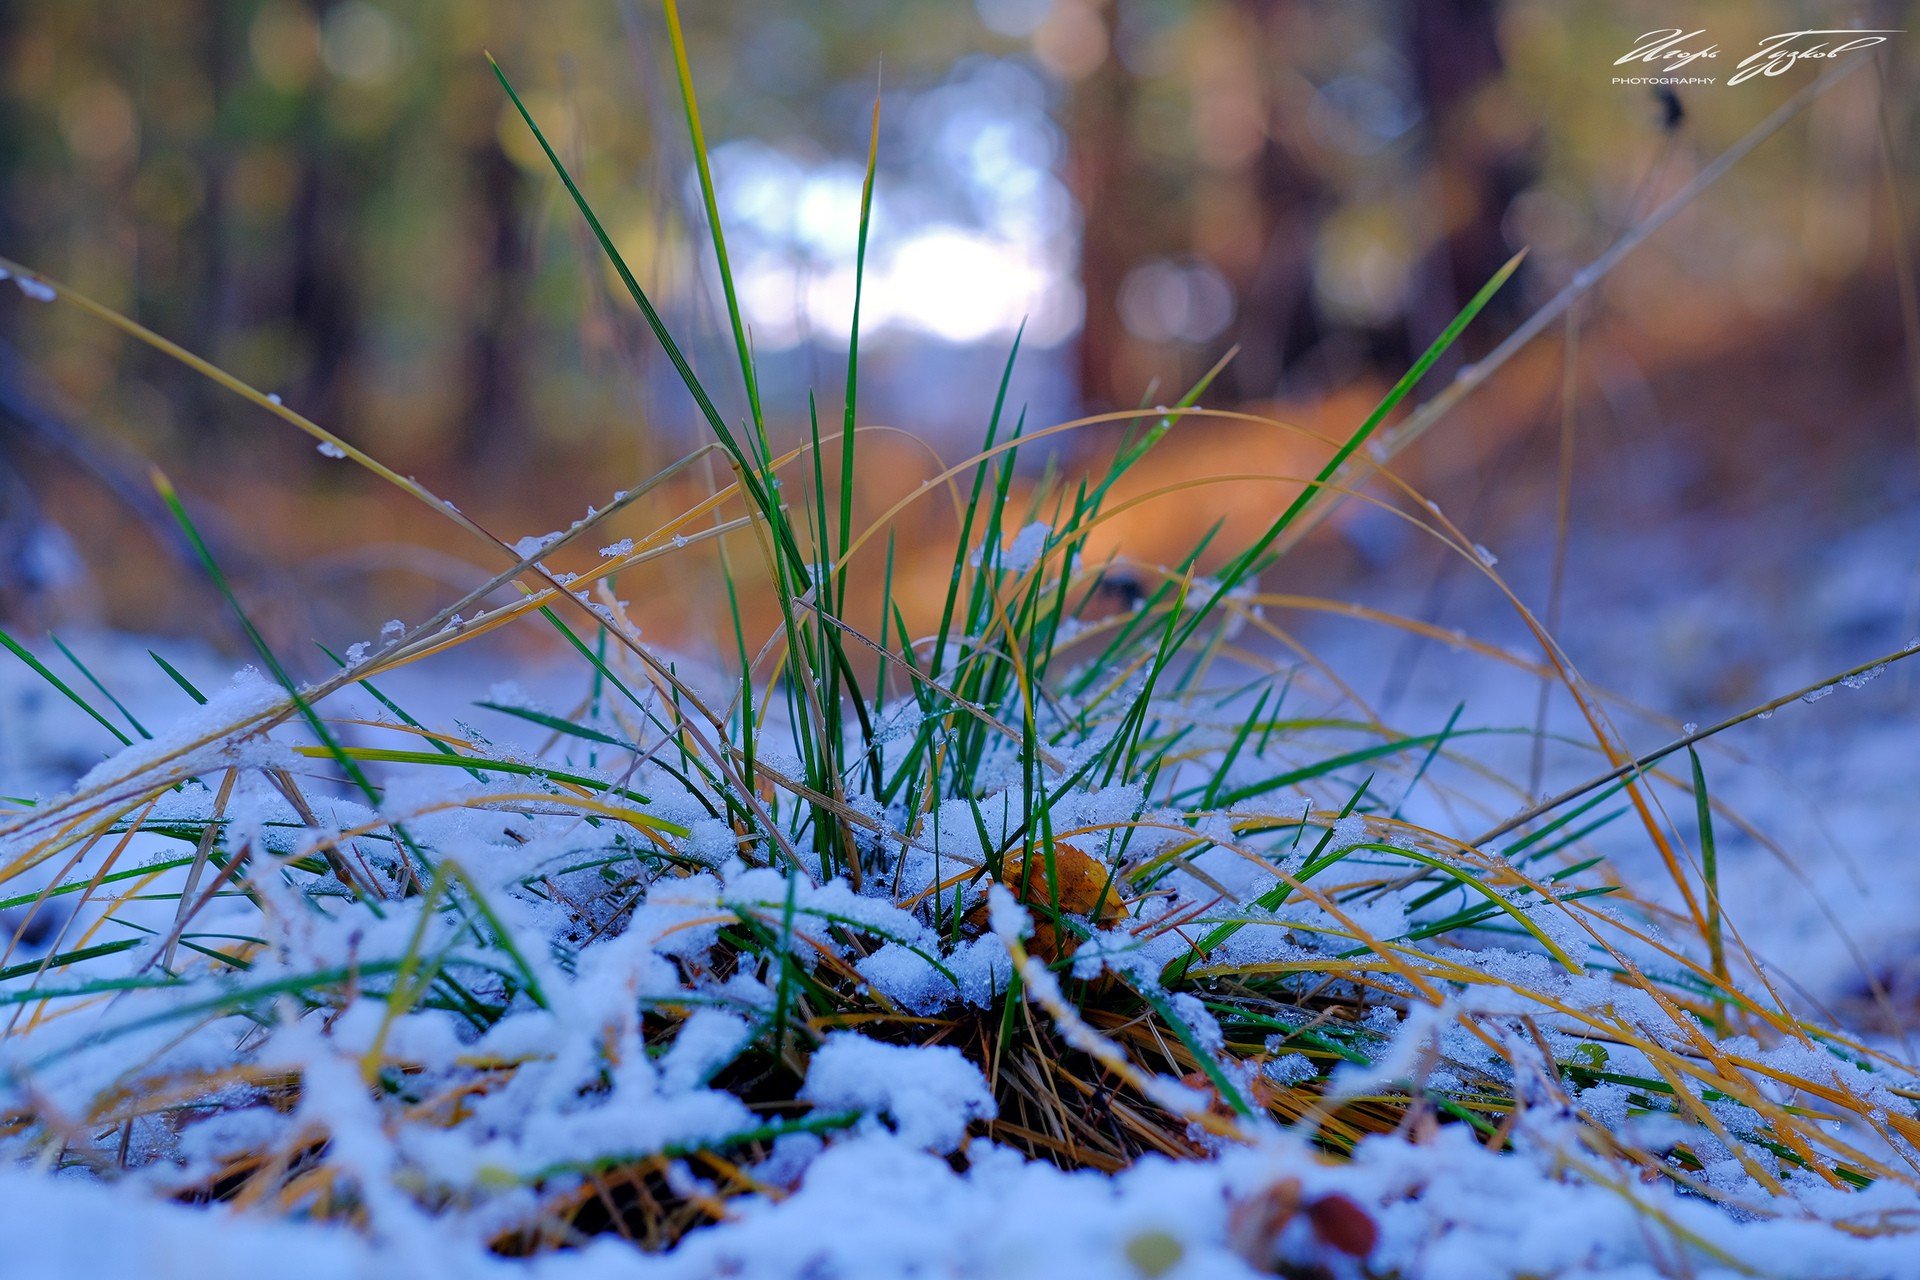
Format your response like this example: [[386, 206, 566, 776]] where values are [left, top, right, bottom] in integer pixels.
[[15, 1128, 1914, 1280]]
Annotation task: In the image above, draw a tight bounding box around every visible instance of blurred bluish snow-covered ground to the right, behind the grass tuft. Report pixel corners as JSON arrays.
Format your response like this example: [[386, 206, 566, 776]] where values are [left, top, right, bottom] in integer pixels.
[[1300, 455, 1920, 1027]]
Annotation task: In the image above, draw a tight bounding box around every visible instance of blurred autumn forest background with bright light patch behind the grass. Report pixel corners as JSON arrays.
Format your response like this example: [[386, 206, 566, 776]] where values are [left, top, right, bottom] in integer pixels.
[[0, 0, 1920, 690]]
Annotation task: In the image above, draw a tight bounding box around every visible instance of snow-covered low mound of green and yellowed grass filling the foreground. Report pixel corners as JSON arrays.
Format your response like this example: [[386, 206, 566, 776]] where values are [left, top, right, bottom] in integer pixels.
[[11, 498, 1920, 1280]]
